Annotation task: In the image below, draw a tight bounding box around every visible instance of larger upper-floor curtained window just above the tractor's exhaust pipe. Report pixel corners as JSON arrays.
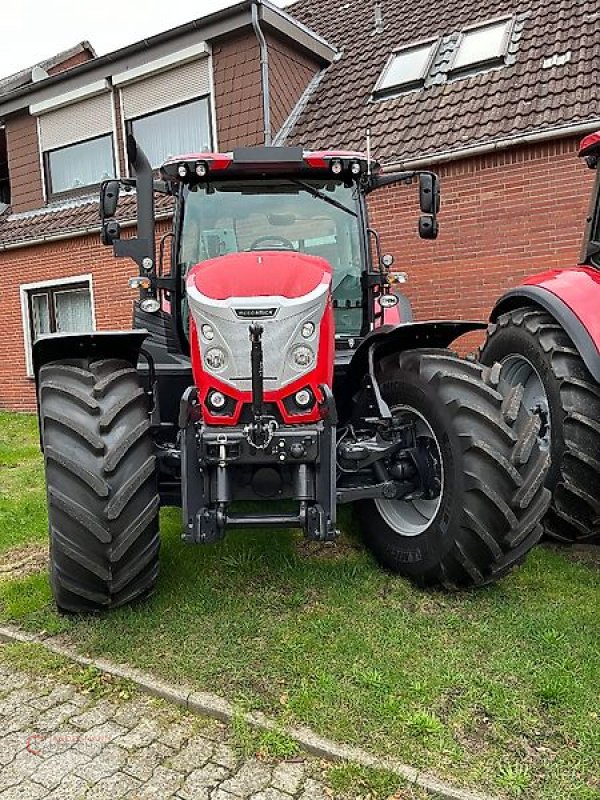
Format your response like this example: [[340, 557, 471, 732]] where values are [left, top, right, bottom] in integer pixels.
[[128, 97, 212, 169]]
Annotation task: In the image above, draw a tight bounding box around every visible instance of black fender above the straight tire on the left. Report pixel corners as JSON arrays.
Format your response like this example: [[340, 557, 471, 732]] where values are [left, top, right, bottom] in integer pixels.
[[32, 329, 149, 385]]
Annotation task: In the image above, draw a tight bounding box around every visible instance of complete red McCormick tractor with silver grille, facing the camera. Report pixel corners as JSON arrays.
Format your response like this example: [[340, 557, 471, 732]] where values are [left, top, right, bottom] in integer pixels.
[[34, 139, 549, 612]]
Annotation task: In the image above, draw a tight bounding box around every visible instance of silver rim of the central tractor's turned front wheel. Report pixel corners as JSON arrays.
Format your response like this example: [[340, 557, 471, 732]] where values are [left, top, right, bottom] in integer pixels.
[[375, 406, 444, 536]]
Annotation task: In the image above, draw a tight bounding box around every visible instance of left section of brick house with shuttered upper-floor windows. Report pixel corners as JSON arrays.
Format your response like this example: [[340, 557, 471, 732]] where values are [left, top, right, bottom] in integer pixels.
[[0, 0, 336, 410]]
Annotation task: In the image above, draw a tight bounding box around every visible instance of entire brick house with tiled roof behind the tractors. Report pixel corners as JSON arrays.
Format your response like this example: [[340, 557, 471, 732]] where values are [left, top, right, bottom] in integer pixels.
[[0, 0, 600, 408]]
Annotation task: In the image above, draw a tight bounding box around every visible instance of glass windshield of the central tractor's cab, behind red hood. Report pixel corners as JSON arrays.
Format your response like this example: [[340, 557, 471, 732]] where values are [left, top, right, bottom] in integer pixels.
[[179, 179, 363, 336]]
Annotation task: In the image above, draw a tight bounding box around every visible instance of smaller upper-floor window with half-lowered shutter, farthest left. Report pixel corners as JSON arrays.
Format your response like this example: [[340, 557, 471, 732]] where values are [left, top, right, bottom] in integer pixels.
[[45, 134, 115, 195]]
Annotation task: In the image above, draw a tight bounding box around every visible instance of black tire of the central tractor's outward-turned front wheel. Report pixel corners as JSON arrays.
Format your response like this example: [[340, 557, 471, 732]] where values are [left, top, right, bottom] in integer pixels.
[[357, 350, 550, 589]]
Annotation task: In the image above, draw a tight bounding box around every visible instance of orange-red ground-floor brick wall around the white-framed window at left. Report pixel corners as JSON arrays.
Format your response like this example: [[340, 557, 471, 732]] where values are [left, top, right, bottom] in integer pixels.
[[0, 222, 169, 411]]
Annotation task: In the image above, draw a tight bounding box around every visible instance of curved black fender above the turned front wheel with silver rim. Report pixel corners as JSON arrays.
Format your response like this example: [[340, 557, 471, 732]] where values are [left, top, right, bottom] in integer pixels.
[[336, 320, 487, 416]]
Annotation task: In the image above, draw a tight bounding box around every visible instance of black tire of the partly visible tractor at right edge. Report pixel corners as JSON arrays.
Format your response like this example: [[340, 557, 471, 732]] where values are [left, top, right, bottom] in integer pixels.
[[480, 306, 600, 544]]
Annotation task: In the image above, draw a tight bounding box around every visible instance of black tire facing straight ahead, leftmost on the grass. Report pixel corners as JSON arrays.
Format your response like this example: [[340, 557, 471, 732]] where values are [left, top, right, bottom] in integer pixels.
[[39, 359, 160, 613]]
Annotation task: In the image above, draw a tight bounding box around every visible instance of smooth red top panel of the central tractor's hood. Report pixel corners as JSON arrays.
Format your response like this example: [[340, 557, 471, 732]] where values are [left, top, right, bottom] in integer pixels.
[[187, 250, 331, 300]]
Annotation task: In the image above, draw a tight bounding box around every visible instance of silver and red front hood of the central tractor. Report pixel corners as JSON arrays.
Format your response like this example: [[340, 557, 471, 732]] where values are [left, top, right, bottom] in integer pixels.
[[186, 250, 333, 393]]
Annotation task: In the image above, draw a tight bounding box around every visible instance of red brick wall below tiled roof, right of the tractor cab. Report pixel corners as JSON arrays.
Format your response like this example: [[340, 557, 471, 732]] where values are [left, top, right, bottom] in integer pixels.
[[370, 134, 593, 346]]
